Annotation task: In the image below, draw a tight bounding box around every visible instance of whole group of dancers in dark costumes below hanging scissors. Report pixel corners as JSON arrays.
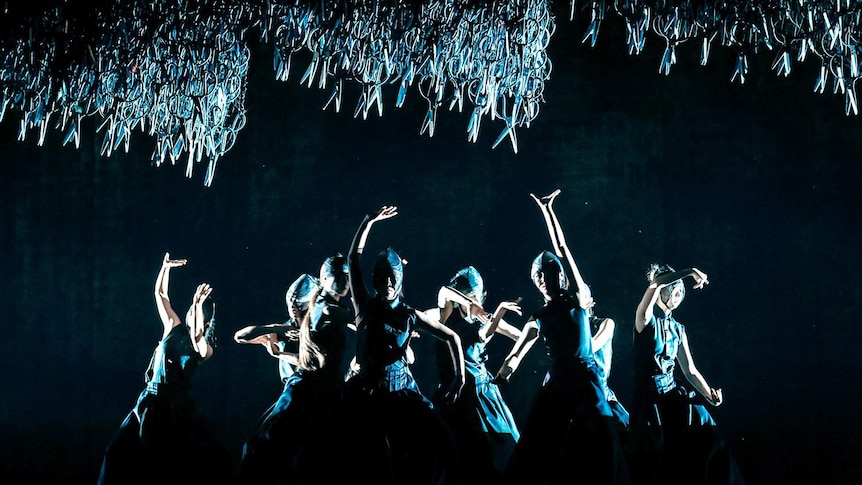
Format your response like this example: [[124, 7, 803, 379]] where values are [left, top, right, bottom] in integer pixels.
[[93, 190, 743, 485]]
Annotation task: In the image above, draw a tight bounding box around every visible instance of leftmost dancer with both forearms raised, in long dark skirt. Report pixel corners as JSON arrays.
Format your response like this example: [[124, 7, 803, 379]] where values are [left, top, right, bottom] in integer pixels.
[[98, 253, 233, 485]]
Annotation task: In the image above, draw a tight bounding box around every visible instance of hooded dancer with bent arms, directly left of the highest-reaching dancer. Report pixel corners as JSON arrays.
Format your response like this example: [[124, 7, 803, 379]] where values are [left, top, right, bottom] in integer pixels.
[[428, 266, 521, 484]]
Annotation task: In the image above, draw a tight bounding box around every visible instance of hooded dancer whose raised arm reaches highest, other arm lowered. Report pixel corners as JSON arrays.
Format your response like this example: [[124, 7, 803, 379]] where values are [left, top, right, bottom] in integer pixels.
[[498, 192, 628, 484]]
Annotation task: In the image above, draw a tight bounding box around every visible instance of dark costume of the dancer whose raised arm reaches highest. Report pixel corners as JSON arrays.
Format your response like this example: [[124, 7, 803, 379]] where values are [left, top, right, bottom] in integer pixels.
[[507, 293, 628, 485]]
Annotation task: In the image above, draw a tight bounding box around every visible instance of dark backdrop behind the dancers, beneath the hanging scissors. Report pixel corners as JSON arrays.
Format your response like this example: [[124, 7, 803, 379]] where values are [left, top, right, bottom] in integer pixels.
[[0, 10, 862, 484]]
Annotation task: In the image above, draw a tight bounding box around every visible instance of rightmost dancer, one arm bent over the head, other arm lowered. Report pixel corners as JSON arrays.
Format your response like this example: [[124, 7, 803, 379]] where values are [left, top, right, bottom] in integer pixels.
[[632, 264, 743, 484]]
